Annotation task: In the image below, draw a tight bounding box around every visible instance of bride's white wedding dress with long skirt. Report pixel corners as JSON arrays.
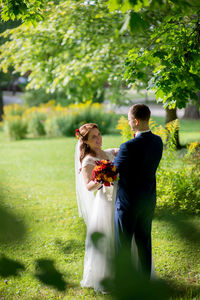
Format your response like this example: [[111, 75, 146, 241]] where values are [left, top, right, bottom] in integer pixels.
[[75, 143, 156, 291]]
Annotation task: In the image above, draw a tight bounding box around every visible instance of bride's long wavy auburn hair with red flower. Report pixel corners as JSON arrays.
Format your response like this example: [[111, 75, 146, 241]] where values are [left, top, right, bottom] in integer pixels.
[[79, 123, 99, 163]]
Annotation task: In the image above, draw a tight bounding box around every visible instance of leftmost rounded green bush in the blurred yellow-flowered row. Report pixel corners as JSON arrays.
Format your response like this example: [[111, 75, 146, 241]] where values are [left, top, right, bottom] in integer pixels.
[[4, 116, 27, 140]]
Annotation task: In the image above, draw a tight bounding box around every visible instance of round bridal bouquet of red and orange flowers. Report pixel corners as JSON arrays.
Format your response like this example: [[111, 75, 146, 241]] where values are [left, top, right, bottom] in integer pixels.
[[93, 160, 118, 186]]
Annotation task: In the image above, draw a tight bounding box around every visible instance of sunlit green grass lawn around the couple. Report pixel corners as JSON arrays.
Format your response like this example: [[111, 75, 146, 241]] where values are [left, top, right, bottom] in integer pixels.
[[0, 129, 200, 300]]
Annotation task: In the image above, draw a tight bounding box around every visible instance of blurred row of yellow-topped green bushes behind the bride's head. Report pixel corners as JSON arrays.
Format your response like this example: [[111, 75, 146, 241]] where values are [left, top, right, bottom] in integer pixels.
[[2, 100, 116, 137]]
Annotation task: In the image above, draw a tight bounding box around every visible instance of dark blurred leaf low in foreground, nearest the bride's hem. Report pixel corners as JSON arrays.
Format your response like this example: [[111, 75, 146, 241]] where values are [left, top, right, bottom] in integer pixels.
[[34, 259, 67, 292]]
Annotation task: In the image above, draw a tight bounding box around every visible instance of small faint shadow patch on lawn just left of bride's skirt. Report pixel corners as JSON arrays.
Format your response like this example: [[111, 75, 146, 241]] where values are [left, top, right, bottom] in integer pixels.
[[55, 239, 85, 254]]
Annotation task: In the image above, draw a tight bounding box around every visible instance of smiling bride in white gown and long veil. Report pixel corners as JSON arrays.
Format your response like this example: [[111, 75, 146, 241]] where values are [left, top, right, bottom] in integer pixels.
[[75, 123, 118, 291]]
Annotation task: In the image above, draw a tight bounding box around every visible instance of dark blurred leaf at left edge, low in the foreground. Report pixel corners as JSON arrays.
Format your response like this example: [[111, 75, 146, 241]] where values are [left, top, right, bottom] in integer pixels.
[[0, 255, 25, 278]]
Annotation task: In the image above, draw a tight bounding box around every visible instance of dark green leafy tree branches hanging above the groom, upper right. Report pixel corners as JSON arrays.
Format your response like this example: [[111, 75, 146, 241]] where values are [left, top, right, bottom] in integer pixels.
[[109, 0, 200, 146]]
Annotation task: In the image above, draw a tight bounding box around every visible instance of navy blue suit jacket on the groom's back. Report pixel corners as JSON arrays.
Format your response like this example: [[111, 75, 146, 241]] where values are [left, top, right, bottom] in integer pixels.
[[114, 131, 163, 211]]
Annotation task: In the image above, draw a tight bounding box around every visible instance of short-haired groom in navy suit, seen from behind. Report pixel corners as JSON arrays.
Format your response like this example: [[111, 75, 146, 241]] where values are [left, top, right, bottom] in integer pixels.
[[114, 104, 163, 278]]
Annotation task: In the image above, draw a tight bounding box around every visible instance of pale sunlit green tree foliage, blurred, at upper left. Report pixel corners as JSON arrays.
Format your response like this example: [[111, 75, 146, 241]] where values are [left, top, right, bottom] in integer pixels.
[[0, 0, 134, 101]]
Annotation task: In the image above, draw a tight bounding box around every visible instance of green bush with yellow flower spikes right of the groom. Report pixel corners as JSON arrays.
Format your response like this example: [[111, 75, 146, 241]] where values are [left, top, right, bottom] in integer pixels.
[[157, 133, 200, 214]]
